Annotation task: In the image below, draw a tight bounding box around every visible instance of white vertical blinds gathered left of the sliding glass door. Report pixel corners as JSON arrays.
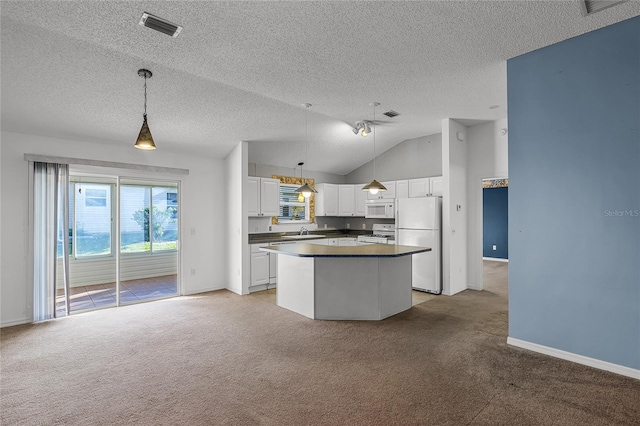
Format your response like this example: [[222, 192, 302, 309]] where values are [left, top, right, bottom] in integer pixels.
[[33, 162, 69, 321]]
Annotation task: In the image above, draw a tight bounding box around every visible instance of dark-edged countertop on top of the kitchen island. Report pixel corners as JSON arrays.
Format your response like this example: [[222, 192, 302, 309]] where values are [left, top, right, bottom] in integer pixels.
[[260, 243, 431, 257]]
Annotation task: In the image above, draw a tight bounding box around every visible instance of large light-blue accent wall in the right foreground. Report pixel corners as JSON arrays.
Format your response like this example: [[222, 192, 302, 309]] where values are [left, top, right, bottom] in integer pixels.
[[507, 17, 640, 369]]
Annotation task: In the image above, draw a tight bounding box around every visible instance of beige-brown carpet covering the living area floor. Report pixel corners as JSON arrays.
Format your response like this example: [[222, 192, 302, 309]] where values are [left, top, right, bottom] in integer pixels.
[[0, 262, 640, 425]]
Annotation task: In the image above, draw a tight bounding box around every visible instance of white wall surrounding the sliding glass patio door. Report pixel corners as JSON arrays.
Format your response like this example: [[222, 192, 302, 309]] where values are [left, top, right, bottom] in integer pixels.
[[0, 132, 227, 326]]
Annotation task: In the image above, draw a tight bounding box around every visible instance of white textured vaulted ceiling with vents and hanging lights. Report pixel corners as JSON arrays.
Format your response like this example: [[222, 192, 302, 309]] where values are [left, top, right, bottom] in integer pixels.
[[0, 0, 640, 174]]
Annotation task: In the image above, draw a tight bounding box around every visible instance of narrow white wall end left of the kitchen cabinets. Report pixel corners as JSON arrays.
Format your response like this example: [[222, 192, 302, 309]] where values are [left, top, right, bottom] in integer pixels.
[[224, 142, 246, 294]]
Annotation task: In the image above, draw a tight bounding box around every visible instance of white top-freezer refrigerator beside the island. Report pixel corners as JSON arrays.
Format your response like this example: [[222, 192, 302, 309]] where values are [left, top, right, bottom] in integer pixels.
[[396, 197, 442, 294]]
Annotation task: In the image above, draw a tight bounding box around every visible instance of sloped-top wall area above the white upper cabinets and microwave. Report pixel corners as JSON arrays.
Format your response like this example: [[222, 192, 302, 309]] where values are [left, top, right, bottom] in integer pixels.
[[345, 134, 442, 184]]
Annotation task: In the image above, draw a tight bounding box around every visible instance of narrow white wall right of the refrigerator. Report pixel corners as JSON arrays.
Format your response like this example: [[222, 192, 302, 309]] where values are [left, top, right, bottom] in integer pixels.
[[442, 119, 468, 295]]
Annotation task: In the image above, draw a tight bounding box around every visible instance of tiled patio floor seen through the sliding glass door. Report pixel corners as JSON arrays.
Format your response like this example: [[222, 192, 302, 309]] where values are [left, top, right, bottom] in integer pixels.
[[56, 275, 178, 313]]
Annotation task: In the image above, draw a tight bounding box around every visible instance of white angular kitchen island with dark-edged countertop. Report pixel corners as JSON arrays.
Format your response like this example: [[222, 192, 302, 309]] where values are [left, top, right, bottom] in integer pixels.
[[260, 243, 431, 320]]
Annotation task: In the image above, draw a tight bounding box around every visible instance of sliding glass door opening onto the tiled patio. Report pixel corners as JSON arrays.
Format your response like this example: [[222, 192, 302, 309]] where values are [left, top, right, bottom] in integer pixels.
[[56, 174, 179, 316]]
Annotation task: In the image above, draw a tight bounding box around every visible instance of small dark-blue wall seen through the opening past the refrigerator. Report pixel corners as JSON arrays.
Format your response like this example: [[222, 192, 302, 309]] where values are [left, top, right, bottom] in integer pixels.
[[482, 187, 509, 259]]
